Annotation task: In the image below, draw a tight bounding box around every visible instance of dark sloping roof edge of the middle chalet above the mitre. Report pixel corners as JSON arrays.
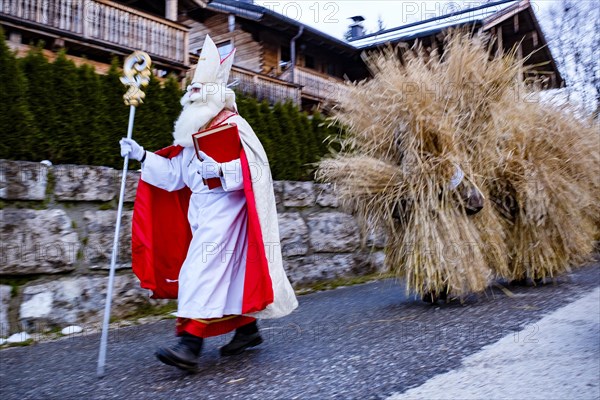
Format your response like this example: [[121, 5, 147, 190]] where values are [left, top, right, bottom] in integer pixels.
[[206, 0, 356, 56]]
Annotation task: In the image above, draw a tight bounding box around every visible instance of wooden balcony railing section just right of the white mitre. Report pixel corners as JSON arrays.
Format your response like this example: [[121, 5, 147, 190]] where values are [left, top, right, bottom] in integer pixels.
[[229, 66, 300, 105]]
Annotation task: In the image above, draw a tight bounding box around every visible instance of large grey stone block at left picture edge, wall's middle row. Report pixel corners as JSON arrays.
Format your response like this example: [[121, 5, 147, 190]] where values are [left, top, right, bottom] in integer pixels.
[[0, 209, 79, 275]]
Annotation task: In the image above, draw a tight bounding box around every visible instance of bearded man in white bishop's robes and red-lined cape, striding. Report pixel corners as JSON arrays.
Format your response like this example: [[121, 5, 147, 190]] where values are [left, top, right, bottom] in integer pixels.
[[120, 36, 298, 370]]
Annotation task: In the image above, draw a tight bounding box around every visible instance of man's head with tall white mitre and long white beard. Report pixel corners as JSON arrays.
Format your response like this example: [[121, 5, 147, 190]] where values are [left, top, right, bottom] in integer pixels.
[[173, 35, 237, 147]]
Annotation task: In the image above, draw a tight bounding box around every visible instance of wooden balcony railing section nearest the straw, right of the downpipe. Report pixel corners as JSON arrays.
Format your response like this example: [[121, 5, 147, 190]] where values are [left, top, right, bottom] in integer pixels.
[[280, 66, 346, 102]]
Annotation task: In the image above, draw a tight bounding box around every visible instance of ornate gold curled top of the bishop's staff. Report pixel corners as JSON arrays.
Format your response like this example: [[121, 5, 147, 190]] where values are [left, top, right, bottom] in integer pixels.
[[121, 51, 152, 107]]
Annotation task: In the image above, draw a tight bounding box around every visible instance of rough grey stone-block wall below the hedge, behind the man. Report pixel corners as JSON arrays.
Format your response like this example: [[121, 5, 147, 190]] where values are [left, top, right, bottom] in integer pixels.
[[0, 160, 385, 337]]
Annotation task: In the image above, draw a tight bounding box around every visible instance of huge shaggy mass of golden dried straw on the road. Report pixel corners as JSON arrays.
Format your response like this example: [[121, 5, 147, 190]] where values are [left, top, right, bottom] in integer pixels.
[[317, 32, 600, 296]]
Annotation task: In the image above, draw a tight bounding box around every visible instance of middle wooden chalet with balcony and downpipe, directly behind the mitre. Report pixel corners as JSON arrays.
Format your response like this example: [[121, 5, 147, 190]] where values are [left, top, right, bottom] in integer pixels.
[[181, 0, 368, 108]]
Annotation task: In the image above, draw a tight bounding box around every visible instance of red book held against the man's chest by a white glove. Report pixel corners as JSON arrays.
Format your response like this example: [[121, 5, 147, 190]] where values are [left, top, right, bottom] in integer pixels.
[[192, 124, 242, 189]]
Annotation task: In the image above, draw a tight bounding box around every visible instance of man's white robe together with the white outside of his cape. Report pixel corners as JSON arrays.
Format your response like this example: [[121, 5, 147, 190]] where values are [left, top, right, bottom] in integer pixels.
[[142, 116, 298, 318]]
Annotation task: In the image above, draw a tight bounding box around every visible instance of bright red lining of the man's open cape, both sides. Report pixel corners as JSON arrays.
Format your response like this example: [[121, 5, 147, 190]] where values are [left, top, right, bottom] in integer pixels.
[[131, 120, 273, 314]]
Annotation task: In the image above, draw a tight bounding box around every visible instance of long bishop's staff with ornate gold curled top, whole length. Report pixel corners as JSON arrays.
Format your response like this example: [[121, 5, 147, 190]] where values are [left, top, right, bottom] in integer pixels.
[[98, 51, 151, 377]]
